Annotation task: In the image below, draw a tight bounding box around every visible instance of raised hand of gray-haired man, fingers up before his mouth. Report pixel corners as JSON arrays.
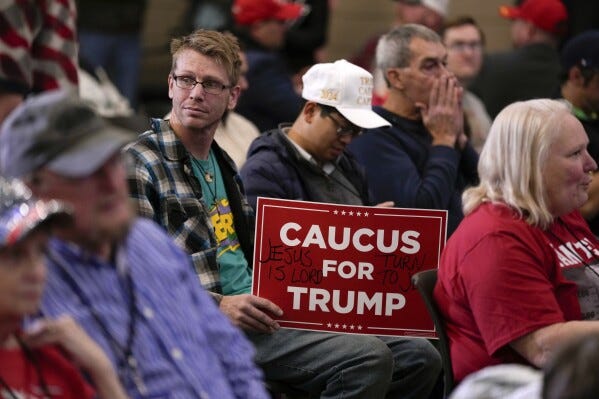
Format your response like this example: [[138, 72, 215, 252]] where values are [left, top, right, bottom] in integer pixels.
[[416, 74, 464, 147]]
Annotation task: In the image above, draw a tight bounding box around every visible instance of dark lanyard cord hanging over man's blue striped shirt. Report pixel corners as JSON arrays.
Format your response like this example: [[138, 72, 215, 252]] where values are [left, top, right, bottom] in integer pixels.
[[46, 251, 147, 395]]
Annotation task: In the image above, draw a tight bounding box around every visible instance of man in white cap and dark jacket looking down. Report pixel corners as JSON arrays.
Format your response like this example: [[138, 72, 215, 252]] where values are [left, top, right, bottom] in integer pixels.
[[241, 60, 390, 207]]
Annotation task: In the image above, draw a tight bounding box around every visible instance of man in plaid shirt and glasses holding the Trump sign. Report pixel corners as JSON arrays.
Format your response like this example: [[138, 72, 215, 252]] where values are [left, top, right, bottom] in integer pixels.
[[127, 31, 441, 398]]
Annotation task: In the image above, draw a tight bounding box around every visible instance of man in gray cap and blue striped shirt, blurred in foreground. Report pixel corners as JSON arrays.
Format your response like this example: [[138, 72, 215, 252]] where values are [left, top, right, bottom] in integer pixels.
[[0, 92, 268, 399]]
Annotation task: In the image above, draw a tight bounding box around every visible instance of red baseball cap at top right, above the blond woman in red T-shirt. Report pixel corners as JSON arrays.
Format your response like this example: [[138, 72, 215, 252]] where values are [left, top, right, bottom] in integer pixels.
[[499, 0, 568, 35]]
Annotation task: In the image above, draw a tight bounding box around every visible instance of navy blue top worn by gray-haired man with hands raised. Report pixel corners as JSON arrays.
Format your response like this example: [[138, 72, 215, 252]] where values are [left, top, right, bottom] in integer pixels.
[[349, 107, 478, 236]]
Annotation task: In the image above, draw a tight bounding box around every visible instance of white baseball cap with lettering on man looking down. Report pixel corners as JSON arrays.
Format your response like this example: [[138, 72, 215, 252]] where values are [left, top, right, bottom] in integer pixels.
[[302, 60, 391, 129]]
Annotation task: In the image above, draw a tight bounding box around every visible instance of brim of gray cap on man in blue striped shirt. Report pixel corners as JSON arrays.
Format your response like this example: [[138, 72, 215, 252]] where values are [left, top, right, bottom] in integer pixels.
[[46, 126, 134, 177]]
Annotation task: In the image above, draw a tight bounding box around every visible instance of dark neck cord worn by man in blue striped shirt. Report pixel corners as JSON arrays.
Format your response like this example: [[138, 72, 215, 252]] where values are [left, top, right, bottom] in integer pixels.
[[47, 253, 139, 386]]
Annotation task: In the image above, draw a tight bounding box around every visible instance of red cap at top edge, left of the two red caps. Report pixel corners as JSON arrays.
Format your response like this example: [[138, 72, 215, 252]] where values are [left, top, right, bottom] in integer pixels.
[[233, 0, 304, 25]]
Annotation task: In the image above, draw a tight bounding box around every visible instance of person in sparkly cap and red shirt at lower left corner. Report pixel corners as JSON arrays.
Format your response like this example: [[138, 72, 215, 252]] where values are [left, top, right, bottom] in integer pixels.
[[0, 179, 127, 399]]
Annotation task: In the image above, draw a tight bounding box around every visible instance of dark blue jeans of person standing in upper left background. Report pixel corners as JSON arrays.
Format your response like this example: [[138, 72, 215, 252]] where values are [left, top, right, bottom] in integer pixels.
[[78, 31, 141, 108]]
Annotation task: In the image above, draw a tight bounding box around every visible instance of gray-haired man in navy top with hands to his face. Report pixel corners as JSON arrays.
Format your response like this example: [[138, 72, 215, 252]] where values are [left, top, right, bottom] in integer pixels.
[[347, 24, 478, 235]]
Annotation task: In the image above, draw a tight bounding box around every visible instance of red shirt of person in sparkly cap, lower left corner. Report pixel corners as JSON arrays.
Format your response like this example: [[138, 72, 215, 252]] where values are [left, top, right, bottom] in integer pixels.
[[0, 346, 95, 399]]
